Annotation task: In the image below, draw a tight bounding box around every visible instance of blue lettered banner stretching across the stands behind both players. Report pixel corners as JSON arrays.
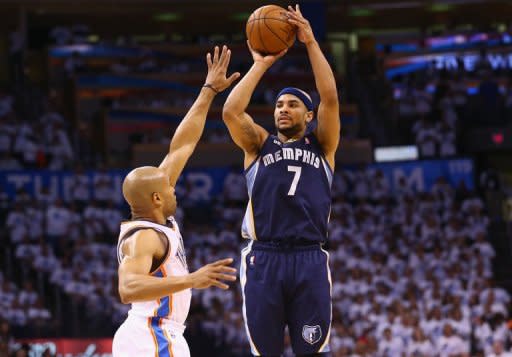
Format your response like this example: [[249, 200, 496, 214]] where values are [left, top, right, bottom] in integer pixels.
[[0, 158, 474, 200]]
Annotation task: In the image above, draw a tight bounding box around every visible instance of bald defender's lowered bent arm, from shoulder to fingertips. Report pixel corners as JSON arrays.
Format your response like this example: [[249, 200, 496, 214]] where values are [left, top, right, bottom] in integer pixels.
[[119, 229, 236, 304]]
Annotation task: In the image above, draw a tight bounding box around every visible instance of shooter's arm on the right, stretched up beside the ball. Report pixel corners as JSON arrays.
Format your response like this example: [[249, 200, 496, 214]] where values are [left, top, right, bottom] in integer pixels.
[[287, 5, 340, 168]]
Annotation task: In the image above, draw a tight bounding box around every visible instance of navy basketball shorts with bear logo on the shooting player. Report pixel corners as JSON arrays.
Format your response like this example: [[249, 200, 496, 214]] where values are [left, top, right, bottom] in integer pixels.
[[240, 241, 332, 356]]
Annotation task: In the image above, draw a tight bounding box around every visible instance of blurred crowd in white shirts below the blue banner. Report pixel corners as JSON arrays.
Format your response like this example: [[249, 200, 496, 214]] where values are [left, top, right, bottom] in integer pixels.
[[0, 162, 511, 357]]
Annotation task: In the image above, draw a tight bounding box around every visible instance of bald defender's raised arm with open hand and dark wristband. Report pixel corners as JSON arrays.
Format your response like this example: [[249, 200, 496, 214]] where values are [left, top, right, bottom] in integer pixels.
[[160, 46, 240, 186]]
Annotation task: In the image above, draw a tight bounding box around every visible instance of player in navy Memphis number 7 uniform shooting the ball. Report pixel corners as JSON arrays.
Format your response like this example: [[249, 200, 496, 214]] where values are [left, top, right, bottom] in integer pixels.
[[223, 5, 340, 356]]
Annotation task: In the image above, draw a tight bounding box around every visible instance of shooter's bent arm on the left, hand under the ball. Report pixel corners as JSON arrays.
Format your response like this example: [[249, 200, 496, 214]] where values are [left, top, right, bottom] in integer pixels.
[[222, 42, 286, 167]]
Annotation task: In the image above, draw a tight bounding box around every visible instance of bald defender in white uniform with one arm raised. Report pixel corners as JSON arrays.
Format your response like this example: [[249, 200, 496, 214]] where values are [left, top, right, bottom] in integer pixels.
[[113, 46, 240, 357]]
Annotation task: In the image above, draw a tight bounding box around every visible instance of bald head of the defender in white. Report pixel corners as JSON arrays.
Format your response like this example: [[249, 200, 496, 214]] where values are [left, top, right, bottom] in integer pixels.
[[123, 166, 175, 211]]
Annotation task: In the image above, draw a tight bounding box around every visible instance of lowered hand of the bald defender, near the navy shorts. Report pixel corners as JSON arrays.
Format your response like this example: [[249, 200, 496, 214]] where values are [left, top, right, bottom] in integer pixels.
[[190, 258, 236, 290]]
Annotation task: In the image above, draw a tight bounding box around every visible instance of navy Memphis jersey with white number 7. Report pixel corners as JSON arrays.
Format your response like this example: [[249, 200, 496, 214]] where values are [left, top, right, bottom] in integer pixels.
[[242, 133, 333, 243]]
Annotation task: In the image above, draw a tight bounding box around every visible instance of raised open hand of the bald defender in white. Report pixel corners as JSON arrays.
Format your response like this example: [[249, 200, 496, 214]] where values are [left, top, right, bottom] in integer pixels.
[[206, 45, 240, 92]]
